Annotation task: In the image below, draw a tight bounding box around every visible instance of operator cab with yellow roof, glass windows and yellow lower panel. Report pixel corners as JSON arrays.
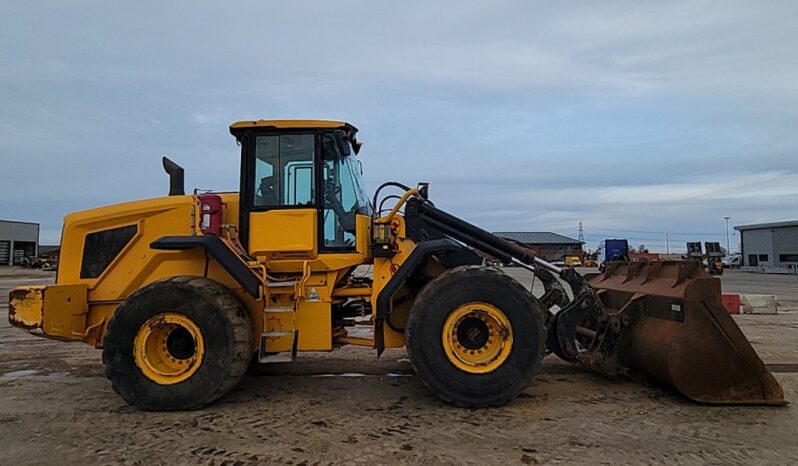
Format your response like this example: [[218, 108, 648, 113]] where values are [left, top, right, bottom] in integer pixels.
[[230, 120, 371, 257]]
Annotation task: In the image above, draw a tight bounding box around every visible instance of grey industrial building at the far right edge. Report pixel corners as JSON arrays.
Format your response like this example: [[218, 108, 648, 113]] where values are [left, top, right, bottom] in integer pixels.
[[734, 220, 798, 273]]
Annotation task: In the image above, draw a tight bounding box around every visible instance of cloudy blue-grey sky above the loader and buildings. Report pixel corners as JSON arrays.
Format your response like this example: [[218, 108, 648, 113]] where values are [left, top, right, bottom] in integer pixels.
[[0, 1, 798, 251]]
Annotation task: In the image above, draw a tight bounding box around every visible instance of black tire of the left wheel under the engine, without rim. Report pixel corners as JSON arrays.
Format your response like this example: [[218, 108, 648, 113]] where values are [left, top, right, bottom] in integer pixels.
[[103, 276, 253, 411]]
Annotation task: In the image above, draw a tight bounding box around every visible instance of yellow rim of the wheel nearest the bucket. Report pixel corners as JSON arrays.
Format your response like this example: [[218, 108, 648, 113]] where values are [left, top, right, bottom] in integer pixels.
[[441, 302, 513, 374]]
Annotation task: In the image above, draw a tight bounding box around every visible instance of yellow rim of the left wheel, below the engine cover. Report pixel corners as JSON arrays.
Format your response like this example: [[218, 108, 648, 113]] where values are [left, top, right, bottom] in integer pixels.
[[134, 312, 205, 385]]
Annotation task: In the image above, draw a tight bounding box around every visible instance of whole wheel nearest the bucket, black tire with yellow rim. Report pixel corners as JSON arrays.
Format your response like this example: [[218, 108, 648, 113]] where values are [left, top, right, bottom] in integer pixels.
[[406, 266, 545, 407]]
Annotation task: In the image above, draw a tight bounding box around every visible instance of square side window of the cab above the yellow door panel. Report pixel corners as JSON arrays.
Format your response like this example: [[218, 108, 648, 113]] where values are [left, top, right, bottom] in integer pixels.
[[253, 134, 316, 207]]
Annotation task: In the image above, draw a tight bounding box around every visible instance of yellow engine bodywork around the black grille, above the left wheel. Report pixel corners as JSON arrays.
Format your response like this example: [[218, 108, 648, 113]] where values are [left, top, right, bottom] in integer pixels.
[[39, 193, 262, 345]]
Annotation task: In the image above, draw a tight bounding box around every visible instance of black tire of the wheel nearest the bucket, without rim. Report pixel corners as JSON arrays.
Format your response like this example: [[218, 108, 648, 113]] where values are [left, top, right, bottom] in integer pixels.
[[406, 266, 546, 408]]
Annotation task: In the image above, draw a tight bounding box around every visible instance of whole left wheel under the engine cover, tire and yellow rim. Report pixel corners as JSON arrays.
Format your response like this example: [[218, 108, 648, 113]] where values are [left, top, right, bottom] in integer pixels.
[[103, 277, 252, 411]]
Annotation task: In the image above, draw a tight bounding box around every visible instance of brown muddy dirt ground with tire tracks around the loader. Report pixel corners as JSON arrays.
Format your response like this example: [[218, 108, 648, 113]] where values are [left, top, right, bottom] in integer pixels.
[[0, 268, 798, 465]]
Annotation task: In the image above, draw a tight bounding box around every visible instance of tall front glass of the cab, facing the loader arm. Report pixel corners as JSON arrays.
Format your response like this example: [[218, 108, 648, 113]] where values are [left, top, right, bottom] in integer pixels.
[[322, 133, 371, 249]]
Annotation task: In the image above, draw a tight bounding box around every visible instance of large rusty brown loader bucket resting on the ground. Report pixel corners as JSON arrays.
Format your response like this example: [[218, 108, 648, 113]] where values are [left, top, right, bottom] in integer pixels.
[[577, 261, 785, 405]]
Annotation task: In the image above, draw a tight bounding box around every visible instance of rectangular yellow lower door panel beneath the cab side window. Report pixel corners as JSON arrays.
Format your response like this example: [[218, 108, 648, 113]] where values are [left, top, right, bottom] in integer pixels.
[[249, 209, 318, 260]]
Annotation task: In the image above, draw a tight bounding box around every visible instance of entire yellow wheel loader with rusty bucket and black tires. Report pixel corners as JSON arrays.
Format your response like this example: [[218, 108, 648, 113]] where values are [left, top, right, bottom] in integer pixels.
[[9, 120, 784, 410]]
